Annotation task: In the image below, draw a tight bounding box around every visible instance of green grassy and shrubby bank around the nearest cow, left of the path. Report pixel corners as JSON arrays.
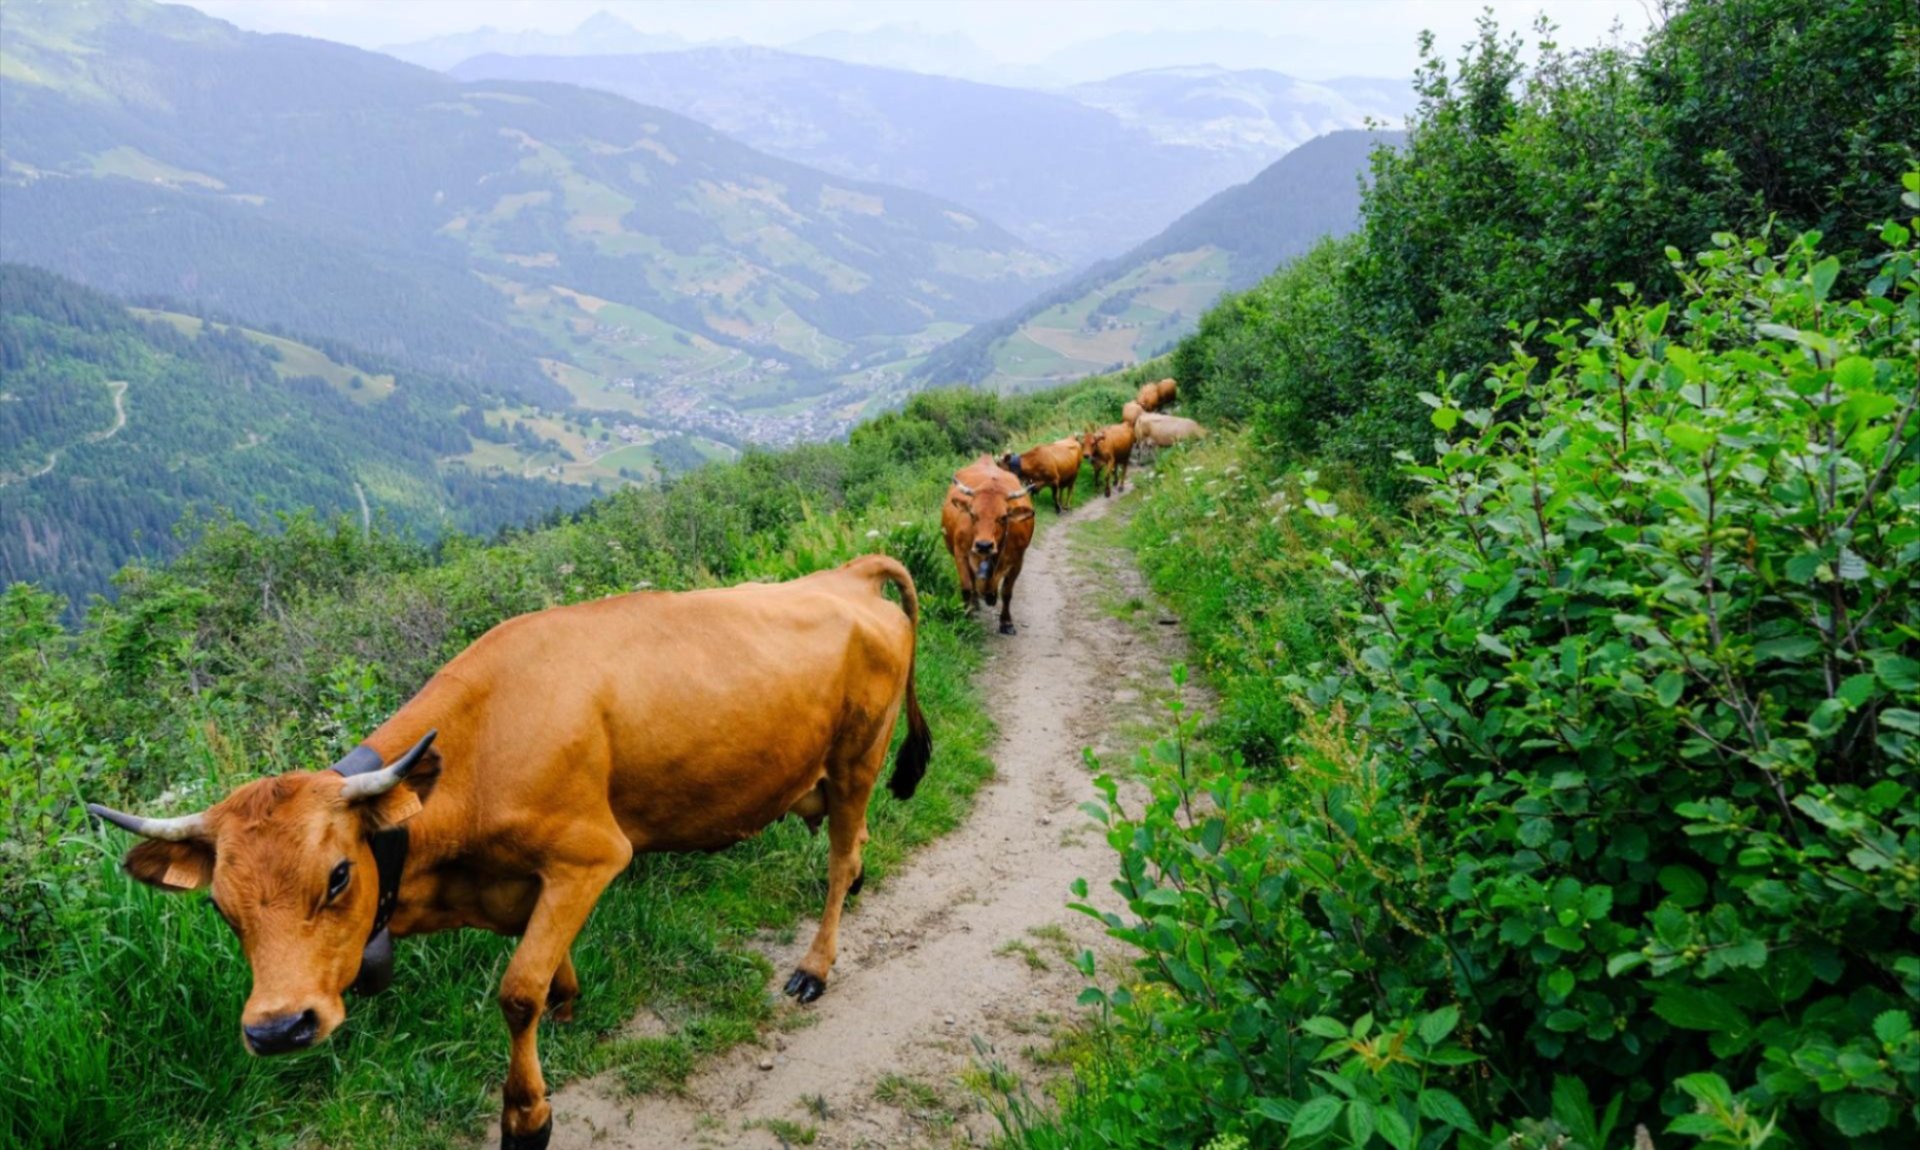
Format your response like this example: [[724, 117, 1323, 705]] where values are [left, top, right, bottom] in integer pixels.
[[0, 370, 1152, 1148]]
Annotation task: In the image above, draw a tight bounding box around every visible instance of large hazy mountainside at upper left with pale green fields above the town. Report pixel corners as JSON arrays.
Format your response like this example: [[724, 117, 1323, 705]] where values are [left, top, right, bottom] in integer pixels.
[[0, 0, 1060, 440]]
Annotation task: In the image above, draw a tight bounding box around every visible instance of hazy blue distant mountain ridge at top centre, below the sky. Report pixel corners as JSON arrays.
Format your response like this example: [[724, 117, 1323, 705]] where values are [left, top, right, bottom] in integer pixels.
[[451, 48, 1290, 265]]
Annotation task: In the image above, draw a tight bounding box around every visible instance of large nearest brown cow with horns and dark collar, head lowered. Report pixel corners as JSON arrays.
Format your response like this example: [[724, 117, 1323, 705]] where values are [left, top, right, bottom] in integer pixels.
[[88, 555, 931, 1150]]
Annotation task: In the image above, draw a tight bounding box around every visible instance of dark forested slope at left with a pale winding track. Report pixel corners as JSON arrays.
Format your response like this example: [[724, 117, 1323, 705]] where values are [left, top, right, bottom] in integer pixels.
[[0, 263, 588, 607]]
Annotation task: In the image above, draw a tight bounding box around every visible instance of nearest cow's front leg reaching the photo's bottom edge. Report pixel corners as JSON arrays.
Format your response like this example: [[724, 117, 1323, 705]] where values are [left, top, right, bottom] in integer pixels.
[[499, 831, 634, 1150]]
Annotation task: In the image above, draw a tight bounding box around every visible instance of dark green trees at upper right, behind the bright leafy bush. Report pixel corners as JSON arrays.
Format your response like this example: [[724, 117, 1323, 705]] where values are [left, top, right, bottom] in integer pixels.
[[1175, 0, 1920, 495]]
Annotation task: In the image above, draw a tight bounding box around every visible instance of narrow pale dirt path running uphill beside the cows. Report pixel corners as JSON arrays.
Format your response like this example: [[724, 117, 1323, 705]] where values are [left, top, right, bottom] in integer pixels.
[[529, 487, 1181, 1150]]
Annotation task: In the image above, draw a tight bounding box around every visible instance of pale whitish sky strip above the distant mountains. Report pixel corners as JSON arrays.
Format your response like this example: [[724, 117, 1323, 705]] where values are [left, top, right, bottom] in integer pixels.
[[172, 0, 1657, 79]]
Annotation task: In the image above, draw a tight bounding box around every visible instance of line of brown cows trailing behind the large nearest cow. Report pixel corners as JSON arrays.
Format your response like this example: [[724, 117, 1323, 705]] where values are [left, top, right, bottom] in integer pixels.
[[941, 380, 1206, 635]]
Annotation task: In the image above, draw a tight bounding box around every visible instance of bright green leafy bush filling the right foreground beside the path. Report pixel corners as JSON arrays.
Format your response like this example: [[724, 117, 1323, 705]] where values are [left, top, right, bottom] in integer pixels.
[[1052, 200, 1920, 1150]]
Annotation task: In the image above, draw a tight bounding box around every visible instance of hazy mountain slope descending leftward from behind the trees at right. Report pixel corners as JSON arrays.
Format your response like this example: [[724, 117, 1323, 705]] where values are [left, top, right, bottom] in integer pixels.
[[916, 132, 1400, 390]]
